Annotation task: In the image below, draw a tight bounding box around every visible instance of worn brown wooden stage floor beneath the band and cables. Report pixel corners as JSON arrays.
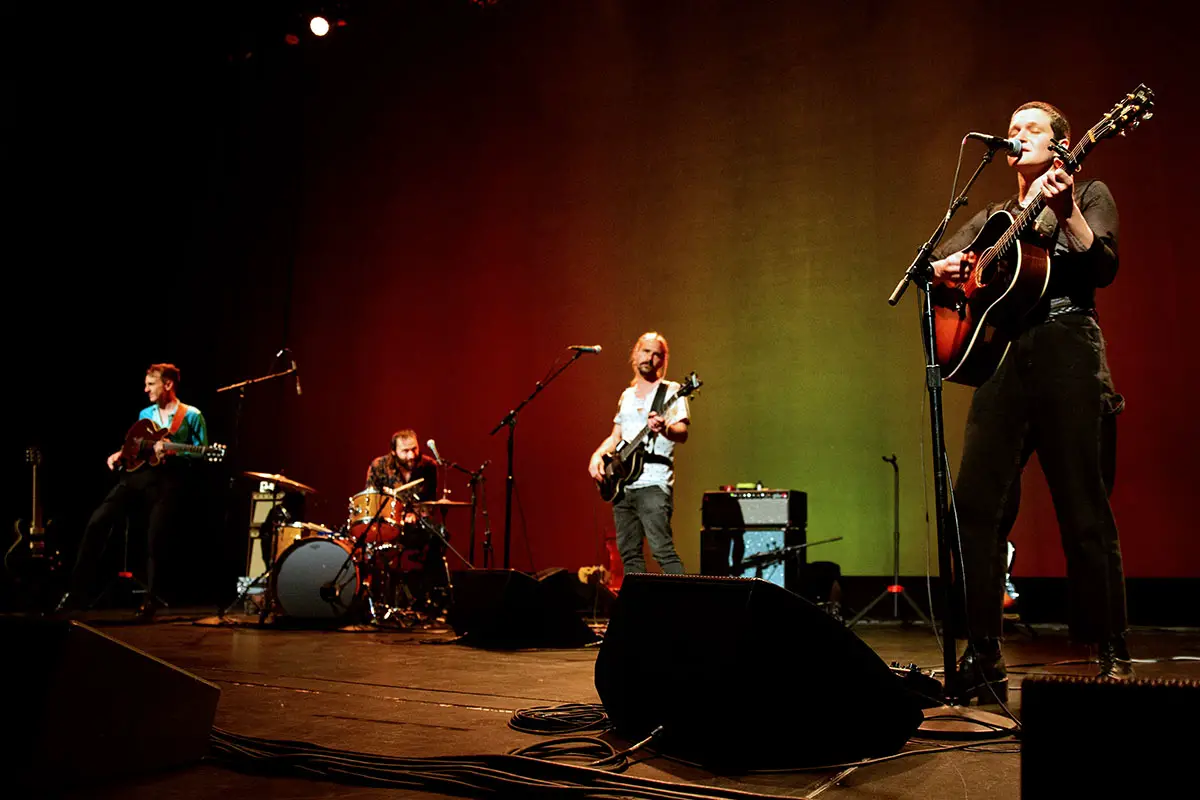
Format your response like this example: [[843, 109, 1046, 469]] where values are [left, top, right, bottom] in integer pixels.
[[37, 610, 1200, 800]]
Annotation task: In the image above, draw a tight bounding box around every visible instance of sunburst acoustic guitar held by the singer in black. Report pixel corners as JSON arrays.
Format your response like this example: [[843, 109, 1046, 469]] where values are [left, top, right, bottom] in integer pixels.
[[930, 84, 1154, 386]]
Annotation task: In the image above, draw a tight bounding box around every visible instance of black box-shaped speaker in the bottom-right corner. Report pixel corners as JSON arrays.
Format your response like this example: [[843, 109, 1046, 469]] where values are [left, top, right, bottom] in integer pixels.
[[1021, 675, 1200, 800]]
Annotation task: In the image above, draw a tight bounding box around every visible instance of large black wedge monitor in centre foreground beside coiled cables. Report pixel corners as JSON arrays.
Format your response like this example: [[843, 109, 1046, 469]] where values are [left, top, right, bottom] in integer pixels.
[[595, 575, 922, 770]]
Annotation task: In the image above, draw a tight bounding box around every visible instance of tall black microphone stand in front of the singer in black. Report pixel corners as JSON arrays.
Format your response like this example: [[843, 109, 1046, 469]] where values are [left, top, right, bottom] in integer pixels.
[[888, 145, 997, 703]]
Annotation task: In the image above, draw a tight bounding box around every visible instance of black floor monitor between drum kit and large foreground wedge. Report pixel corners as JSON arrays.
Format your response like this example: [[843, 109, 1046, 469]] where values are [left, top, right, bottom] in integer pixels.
[[449, 570, 599, 650]]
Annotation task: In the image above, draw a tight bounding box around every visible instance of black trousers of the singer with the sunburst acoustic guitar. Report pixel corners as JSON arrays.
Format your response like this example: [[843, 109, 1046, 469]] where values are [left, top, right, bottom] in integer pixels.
[[952, 314, 1127, 643]]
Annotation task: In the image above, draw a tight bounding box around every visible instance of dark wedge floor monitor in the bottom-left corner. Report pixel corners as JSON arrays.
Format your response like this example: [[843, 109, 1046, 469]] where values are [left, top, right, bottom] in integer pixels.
[[0, 616, 221, 793]]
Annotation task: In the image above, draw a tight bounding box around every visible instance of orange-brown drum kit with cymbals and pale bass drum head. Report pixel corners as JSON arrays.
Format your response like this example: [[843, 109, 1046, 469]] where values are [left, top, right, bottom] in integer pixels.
[[230, 473, 472, 628]]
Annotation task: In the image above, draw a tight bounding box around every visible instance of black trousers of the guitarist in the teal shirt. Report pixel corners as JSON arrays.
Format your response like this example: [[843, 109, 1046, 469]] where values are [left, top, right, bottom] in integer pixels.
[[70, 464, 187, 603]]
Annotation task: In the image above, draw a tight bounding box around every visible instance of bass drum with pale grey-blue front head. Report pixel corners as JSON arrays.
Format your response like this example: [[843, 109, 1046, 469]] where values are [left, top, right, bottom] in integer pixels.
[[271, 536, 362, 619]]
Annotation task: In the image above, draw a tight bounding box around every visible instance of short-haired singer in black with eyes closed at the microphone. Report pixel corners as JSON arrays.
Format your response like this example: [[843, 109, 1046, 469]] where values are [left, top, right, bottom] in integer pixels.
[[932, 102, 1133, 703]]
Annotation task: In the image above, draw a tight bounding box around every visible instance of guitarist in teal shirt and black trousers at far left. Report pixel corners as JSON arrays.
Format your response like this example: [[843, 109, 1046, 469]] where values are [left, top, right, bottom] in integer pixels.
[[59, 363, 209, 621]]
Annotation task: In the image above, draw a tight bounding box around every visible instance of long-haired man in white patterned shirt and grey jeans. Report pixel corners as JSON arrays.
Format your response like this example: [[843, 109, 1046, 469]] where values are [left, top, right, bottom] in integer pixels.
[[588, 332, 691, 575]]
